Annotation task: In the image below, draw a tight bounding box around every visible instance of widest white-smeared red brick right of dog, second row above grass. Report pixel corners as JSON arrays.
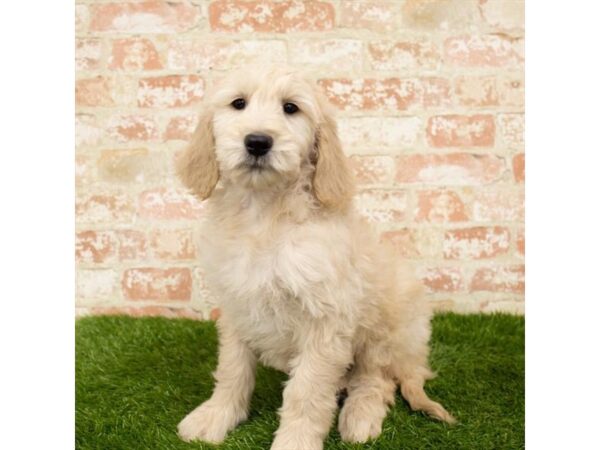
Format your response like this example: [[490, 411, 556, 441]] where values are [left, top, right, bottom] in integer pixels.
[[443, 227, 510, 259]]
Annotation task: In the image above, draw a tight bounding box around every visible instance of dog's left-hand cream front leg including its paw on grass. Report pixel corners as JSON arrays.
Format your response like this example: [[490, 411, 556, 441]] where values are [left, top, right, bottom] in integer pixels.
[[178, 317, 256, 443]]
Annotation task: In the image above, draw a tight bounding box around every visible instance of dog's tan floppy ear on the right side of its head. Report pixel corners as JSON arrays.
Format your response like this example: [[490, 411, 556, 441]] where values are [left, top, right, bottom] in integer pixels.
[[313, 95, 354, 209]]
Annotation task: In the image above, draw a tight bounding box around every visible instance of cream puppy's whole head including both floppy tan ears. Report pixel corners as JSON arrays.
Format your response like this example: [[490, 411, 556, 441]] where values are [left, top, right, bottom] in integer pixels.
[[178, 68, 353, 209]]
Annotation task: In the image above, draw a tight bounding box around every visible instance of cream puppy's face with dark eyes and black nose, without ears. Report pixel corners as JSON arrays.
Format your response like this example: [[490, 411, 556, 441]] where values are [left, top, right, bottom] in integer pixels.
[[212, 70, 320, 189]]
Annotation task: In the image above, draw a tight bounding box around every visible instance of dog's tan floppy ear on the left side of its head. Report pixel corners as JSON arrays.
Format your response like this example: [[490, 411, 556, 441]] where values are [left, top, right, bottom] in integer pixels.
[[177, 107, 219, 200]]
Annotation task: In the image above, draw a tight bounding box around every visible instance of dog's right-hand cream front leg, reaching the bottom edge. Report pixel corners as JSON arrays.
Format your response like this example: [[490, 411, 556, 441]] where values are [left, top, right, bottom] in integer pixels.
[[271, 328, 352, 450]]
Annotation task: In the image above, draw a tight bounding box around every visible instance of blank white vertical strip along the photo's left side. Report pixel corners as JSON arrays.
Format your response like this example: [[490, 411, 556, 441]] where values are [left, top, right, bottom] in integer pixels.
[[0, 1, 75, 449]]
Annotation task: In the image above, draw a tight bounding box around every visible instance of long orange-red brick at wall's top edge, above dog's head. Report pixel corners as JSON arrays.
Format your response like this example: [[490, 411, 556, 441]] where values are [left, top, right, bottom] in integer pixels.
[[208, 0, 335, 33]]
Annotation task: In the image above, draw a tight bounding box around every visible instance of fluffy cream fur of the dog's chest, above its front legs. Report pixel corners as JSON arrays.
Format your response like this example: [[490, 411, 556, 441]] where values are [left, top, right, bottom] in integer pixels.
[[206, 220, 346, 371]]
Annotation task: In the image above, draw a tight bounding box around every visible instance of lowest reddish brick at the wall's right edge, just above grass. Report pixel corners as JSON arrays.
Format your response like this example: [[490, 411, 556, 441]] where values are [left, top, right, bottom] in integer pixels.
[[470, 265, 525, 294]]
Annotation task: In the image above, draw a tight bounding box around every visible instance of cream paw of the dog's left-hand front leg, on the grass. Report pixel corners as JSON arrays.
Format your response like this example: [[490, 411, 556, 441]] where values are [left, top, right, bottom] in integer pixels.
[[177, 401, 244, 444]]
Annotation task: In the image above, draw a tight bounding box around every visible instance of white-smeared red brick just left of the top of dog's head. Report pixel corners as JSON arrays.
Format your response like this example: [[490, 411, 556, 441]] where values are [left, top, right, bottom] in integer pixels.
[[137, 75, 204, 108]]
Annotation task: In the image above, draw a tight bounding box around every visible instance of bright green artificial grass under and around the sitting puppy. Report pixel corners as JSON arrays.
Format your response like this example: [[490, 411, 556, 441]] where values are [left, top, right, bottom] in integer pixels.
[[76, 314, 525, 450]]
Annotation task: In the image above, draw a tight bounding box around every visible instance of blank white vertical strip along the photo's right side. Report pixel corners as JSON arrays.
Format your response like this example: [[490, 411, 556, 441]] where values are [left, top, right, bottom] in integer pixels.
[[525, 0, 600, 450]]
